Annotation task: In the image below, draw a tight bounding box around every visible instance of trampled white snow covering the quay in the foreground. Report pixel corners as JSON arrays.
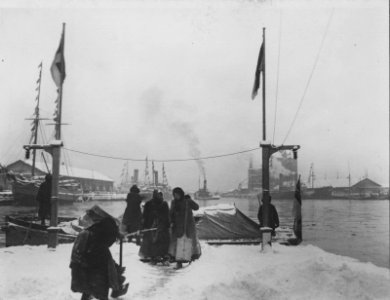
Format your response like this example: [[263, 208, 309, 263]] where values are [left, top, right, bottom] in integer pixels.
[[0, 244, 390, 300]]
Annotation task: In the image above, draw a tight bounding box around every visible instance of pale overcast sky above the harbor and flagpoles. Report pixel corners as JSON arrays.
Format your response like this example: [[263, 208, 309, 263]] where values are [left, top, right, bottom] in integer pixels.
[[0, 0, 389, 190]]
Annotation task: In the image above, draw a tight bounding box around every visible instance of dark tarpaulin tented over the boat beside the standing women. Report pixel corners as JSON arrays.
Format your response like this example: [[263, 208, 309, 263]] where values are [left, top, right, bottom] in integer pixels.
[[196, 208, 260, 240]]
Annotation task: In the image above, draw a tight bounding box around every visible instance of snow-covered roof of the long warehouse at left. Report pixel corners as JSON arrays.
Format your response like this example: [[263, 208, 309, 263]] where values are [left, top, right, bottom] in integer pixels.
[[23, 159, 114, 182]]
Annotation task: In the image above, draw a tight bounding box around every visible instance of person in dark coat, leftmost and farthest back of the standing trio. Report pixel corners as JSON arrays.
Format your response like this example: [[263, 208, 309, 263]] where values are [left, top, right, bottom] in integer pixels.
[[122, 185, 142, 245]]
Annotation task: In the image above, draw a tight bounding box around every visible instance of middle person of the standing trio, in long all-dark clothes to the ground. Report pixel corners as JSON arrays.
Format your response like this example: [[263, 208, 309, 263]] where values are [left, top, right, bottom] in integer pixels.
[[139, 190, 170, 263]]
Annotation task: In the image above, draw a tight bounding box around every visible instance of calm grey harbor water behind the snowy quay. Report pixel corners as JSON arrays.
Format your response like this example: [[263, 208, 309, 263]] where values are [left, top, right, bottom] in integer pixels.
[[0, 198, 389, 268]]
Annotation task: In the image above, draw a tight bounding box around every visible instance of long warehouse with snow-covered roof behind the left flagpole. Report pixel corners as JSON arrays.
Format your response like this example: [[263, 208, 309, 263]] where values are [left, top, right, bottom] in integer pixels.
[[7, 160, 114, 192]]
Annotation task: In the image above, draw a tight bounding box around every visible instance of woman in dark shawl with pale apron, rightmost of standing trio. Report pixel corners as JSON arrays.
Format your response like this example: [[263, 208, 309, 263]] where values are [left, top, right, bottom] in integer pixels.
[[169, 187, 201, 268]]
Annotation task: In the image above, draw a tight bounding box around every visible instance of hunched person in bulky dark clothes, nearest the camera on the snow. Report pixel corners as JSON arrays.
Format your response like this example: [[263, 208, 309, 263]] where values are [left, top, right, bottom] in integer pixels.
[[69, 217, 129, 300]]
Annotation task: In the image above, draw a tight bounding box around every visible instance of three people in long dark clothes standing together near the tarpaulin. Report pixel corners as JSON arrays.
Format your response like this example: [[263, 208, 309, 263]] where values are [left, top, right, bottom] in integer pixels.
[[122, 185, 201, 268]]
